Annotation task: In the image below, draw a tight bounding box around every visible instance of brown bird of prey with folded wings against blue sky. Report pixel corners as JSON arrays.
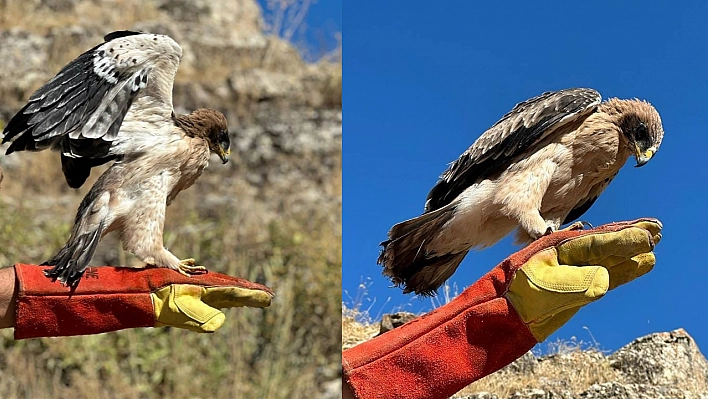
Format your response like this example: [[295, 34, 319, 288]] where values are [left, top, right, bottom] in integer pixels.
[[378, 89, 664, 295]]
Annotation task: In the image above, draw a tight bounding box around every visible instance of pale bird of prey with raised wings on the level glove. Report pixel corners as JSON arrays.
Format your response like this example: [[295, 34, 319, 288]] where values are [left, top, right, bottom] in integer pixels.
[[2, 31, 230, 287]]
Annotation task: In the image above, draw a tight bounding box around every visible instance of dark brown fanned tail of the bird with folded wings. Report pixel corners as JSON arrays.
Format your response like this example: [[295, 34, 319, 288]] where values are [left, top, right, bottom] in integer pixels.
[[377, 202, 468, 296]]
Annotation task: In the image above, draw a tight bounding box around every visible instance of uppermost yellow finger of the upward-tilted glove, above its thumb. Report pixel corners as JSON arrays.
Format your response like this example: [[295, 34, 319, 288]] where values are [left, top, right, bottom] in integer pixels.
[[557, 226, 658, 267]]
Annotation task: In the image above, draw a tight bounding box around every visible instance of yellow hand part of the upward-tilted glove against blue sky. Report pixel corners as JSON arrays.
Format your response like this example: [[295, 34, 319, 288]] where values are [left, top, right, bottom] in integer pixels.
[[506, 219, 663, 342]]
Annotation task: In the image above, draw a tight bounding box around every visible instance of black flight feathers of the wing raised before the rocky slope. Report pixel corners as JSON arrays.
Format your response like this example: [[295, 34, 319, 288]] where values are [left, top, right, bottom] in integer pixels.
[[2, 31, 149, 164]]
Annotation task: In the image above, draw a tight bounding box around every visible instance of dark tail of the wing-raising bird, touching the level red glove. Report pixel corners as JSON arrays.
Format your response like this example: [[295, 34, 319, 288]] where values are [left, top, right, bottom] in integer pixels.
[[42, 223, 104, 288]]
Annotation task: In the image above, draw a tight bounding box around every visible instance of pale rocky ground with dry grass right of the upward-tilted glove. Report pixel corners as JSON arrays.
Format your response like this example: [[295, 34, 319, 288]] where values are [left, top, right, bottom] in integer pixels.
[[455, 329, 708, 399]]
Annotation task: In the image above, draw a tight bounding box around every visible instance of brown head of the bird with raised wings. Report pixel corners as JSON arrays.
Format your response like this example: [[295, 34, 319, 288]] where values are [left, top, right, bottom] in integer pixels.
[[177, 108, 231, 163]]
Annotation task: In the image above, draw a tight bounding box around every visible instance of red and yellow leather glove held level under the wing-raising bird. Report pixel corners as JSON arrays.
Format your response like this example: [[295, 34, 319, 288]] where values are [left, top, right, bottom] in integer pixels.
[[15, 264, 273, 339]]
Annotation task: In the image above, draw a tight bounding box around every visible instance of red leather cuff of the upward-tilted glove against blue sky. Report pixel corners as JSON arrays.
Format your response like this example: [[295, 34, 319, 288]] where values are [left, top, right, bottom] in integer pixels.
[[342, 261, 536, 399]]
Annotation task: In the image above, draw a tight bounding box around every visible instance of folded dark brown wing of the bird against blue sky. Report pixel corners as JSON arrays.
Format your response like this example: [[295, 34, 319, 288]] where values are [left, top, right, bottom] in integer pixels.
[[425, 89, 601, 212]]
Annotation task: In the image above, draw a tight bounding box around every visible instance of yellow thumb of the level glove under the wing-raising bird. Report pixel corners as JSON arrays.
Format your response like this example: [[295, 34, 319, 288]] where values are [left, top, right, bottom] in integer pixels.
[[174, 284, 226, 332]]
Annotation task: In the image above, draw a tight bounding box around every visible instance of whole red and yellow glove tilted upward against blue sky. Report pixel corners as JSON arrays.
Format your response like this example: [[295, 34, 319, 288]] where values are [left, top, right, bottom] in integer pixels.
[[342, 219, 662, 399]]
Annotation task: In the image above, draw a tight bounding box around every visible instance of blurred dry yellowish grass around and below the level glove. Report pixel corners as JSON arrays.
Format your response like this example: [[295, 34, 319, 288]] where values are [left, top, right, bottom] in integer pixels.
[[0, 185, 341, 398]]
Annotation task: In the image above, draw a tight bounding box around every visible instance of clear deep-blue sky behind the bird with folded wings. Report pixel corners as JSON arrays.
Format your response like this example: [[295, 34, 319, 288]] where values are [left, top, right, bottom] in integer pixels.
[[342, 1, 708, 350]]
